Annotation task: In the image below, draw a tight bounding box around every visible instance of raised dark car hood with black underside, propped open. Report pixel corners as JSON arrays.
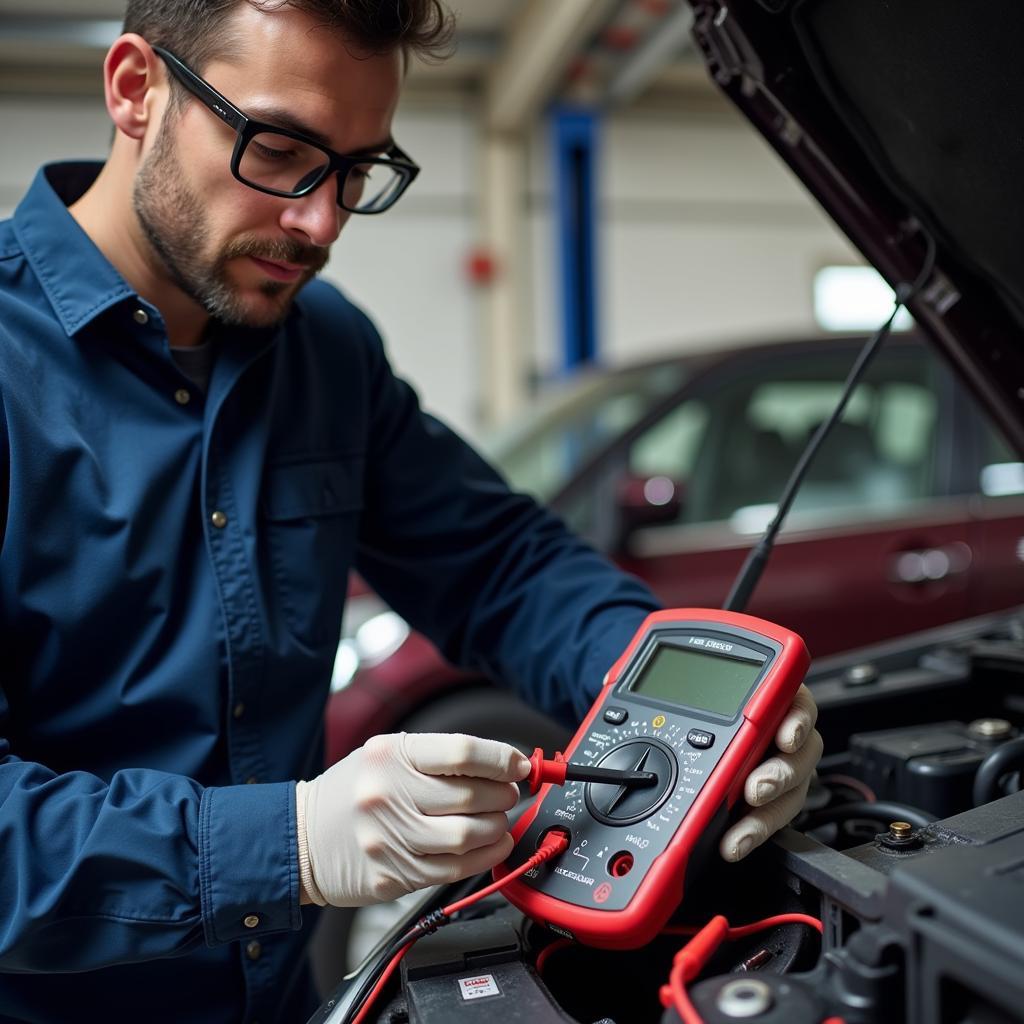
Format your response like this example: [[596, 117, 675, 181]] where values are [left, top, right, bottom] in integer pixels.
[[689, 0, 1024, 454]]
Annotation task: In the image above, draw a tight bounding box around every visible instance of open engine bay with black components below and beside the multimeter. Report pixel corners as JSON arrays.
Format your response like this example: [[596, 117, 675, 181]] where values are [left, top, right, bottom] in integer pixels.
[[311, 611, 1024, 1024]]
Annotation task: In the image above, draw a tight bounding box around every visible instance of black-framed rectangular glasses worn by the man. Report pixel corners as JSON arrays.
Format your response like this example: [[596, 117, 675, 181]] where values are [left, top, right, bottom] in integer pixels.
[[153, 46, 420, 213]]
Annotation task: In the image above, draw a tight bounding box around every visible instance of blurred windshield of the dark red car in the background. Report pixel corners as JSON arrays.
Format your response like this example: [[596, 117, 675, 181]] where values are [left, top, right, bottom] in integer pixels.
[[481, 362, 687, 502]]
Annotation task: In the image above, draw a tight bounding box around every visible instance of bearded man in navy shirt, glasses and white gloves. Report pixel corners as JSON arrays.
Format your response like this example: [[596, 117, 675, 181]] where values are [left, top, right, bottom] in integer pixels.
[[0, 0, 820, 1024]]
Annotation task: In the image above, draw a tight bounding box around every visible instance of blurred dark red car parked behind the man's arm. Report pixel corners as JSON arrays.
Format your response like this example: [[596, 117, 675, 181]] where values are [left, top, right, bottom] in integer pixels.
[[328, 335, 1024, 761]]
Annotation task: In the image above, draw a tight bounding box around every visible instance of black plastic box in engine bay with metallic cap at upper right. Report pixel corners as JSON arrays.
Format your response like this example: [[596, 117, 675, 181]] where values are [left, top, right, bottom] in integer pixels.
[[850, 719, 1017, 818]]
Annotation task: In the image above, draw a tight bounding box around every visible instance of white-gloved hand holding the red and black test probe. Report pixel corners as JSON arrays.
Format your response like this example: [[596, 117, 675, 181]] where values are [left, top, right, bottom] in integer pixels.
[[297, 732, 529, 906]]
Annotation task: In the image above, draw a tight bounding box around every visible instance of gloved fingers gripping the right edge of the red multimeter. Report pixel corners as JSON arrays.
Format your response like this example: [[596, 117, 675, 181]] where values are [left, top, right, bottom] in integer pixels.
[[718, 686, 822, 860]]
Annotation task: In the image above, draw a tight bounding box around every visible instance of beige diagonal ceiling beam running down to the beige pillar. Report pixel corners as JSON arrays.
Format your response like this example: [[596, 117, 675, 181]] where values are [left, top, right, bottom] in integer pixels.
[[484, 0, 621, 132]]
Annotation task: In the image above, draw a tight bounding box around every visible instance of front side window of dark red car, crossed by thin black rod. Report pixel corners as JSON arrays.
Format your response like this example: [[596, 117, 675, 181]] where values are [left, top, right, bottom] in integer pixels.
[[629, 346, 938, 532]]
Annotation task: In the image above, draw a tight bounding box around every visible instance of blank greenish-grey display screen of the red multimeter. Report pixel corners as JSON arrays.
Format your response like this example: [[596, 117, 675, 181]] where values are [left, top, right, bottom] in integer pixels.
[[630, 644, 764, 718]]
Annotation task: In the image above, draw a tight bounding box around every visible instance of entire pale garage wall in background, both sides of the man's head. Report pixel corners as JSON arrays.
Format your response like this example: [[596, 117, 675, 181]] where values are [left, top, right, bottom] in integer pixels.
[[0, 97, 855, 436]]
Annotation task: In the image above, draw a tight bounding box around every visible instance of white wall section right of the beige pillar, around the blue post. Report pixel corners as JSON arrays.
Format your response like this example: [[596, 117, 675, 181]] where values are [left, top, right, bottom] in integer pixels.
[[530, 112, 860, 385]]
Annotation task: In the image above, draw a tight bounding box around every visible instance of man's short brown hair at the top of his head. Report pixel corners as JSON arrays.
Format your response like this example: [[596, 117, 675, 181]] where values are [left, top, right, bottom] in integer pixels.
[[124, 0, 455, 73]]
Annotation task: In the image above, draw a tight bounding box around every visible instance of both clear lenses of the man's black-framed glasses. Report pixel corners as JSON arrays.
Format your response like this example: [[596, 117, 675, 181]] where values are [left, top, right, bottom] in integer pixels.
[[239, 132, 404, 212]]
